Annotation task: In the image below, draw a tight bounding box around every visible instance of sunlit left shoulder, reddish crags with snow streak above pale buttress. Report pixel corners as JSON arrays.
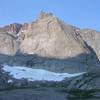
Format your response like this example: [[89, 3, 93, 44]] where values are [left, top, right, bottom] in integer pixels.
[[0, 24, 22, 55]]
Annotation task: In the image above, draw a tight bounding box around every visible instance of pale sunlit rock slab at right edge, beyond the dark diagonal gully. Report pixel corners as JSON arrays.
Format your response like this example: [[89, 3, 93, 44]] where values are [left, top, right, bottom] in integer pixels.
[[81, 29, 100, 59]]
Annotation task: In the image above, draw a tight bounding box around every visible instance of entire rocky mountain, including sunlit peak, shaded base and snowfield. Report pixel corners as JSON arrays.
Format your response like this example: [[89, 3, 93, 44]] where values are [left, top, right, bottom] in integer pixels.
[[0, 12, 100, 94]]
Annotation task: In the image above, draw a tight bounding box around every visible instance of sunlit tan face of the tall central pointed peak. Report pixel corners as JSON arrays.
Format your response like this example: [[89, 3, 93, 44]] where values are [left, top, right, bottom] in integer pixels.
[[19, 13, 89, 58]]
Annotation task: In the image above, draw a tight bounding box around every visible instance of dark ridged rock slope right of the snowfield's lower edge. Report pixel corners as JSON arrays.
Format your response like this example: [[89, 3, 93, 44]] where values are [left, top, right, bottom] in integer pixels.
[[63, 69, 100, 90]]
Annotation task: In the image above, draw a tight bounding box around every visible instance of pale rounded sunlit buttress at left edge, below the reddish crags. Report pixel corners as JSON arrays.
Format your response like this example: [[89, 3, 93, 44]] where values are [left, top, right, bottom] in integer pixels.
[[0, 33, 18, 55]]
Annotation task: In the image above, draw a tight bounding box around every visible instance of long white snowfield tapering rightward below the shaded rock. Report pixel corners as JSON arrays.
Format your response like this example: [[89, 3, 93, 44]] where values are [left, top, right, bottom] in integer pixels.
[[3, 65, 86, 82]]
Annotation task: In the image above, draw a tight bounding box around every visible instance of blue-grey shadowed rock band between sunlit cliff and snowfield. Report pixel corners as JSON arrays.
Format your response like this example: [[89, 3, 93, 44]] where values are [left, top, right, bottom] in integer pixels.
[[0, 54, 99, 73]]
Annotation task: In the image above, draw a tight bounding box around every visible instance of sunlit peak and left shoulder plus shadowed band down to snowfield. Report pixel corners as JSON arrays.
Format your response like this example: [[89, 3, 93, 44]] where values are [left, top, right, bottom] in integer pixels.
[[0, 12, 99, 72]]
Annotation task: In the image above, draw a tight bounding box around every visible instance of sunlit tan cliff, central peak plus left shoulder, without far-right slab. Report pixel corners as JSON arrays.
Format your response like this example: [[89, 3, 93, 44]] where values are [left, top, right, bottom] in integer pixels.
[[0, 12, 99, 58]]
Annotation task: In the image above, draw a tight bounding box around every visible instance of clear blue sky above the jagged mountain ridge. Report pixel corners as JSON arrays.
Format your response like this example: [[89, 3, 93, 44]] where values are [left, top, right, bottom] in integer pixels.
[[0, 0, 100, 31]]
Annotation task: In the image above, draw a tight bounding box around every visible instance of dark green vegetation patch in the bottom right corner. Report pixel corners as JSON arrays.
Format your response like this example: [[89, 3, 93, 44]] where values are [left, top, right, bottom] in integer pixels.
[[63, 89, 100, 100]]
